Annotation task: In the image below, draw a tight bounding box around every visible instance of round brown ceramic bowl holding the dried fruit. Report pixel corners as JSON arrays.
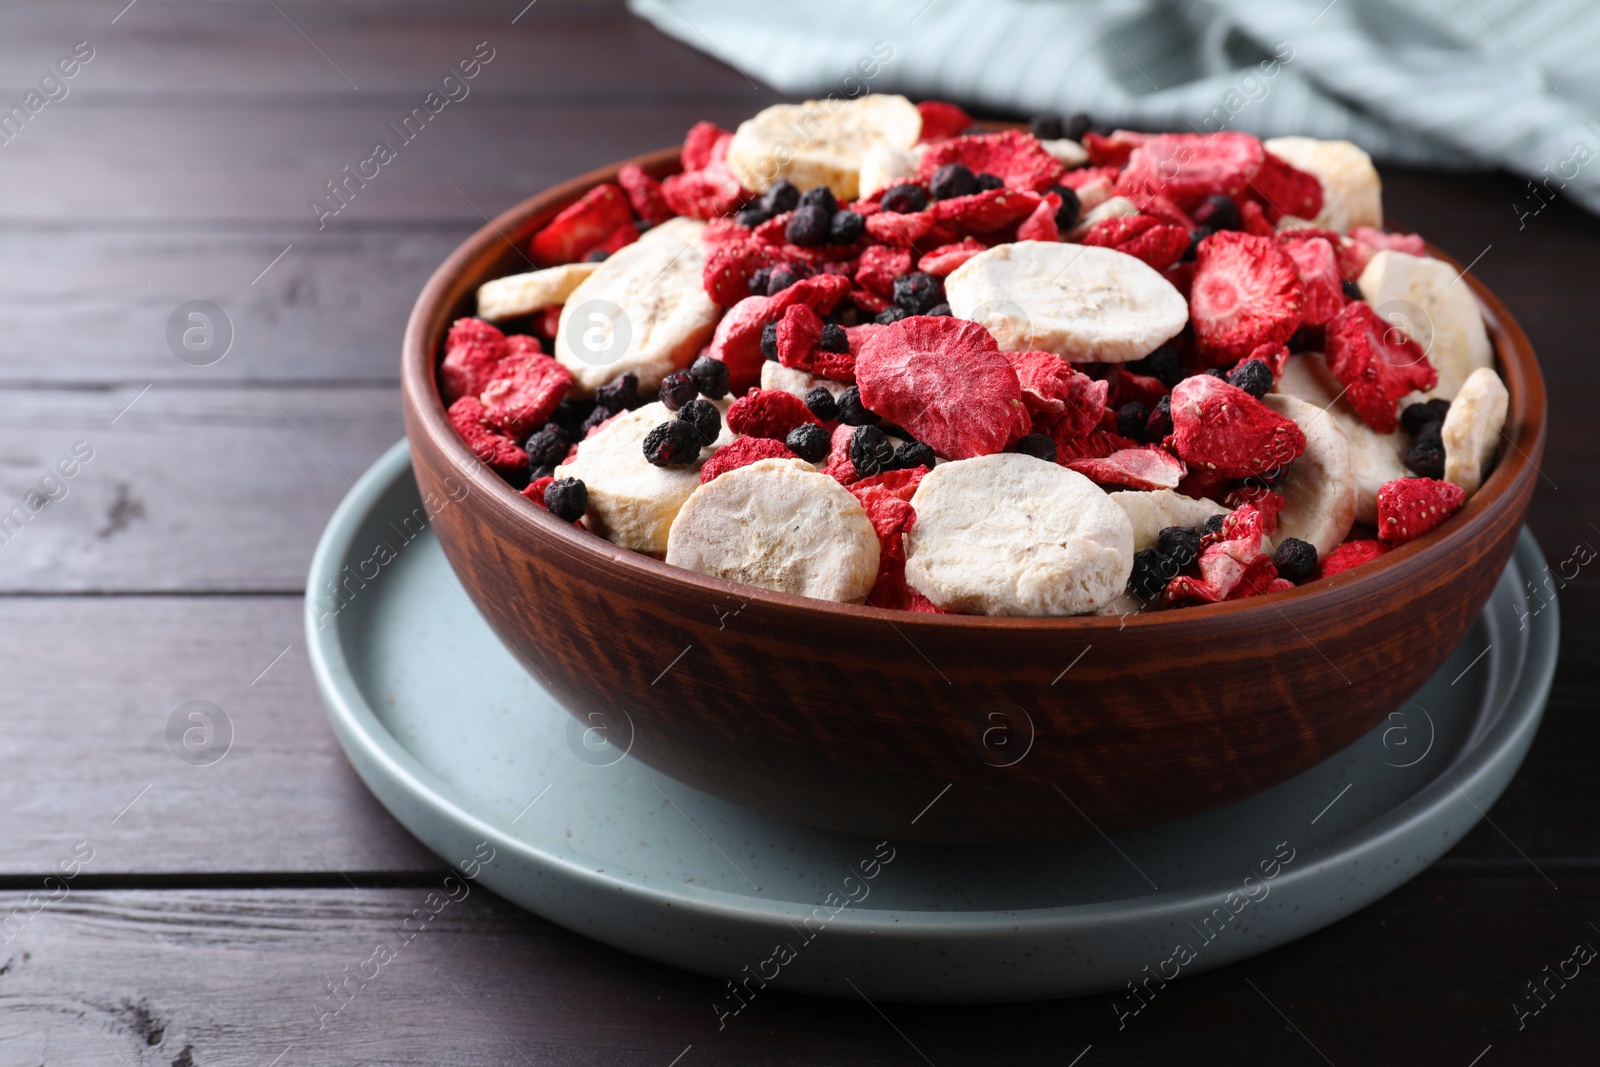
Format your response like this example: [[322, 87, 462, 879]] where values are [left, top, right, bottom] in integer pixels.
[[402, 149, 1544, 841]]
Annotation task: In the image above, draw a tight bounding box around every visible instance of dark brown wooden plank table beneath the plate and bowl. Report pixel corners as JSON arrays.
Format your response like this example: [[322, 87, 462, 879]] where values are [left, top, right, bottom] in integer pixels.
[[0, 0, 1600, 1067]]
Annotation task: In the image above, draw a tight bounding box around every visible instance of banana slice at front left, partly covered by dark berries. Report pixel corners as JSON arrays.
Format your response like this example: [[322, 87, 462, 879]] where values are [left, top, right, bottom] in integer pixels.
[[555, 402, 733, 557]]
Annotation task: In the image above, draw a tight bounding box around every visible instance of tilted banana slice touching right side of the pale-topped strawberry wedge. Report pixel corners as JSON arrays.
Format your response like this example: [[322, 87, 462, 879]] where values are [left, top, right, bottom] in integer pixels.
[[1262, 394, 1357, 558]]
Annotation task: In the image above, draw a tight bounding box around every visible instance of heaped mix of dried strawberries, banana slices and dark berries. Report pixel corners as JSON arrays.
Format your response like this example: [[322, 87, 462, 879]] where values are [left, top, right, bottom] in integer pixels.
[[438, 102, 1509, 614]]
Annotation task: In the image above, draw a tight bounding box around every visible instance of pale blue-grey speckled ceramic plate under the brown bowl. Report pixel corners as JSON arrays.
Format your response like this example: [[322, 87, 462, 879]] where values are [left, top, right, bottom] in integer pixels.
[[307, 442, 1560, 1013]]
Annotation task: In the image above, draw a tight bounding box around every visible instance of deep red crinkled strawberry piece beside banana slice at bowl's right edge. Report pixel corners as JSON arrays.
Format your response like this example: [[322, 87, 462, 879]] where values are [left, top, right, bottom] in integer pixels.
[[1325, 301, 1438, 434]]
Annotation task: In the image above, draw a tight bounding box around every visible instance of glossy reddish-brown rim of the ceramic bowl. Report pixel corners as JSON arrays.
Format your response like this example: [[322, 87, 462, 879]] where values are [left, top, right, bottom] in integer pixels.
[[400, 147, 1546, 633]]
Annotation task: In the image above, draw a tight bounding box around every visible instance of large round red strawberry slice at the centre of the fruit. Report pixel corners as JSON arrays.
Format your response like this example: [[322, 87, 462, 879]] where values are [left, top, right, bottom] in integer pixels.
[[856, 315, 1029, 459]]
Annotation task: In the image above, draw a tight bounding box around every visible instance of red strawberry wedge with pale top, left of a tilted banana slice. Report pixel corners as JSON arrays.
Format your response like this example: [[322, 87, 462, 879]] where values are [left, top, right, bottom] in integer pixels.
[[1168, 374, 1306, 478]]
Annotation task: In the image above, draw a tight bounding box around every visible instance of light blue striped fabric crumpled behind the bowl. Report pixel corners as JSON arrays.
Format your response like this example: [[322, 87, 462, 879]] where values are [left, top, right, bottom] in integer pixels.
[[630, 0, 1600, 219]]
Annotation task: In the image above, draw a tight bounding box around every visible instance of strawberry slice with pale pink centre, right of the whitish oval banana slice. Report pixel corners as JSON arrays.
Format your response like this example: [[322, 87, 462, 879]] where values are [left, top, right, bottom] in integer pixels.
[[1189, 230, 1304, 365]]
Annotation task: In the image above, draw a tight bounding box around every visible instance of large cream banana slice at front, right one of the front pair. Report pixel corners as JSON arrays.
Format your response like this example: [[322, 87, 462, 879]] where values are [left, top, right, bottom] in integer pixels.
[[906, 453, 1133, 616]]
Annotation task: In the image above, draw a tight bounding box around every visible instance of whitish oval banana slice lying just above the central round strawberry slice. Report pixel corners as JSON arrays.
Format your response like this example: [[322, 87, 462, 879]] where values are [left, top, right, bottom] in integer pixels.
[[944, 242, 1189, 363]]
